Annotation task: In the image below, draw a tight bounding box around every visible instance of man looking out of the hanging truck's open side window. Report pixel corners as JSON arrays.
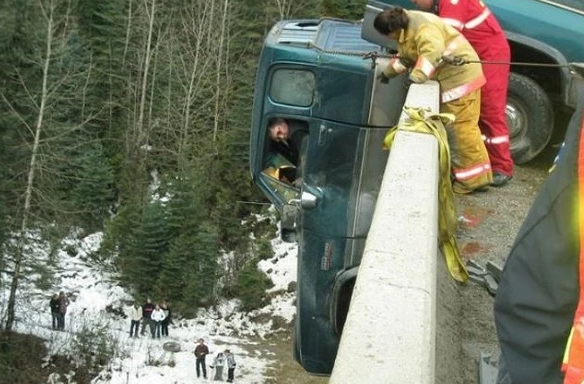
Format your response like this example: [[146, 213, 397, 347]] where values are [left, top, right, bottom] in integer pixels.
[[266, 117, 308, 185]]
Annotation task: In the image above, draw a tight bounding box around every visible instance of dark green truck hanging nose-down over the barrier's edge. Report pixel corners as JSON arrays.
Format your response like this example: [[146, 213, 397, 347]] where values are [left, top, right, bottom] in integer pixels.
[[250, 19, 406, 374]]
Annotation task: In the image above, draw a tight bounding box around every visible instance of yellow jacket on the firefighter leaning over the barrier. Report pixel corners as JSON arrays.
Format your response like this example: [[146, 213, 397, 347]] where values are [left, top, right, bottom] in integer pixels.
[[384, 11, 486, 103]]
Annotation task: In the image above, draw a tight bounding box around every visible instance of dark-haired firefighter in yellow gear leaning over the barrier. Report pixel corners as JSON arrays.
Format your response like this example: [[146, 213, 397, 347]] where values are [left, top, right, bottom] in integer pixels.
[[373, 7, 493, 193]]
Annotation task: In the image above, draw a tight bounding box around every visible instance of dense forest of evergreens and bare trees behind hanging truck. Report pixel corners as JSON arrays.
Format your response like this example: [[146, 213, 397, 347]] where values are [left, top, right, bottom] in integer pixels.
[[0, 0, 365, 331]]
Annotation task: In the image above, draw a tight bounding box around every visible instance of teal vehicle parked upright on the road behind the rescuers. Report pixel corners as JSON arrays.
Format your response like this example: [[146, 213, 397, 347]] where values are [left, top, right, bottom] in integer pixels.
[[364, 0, 584, 164]]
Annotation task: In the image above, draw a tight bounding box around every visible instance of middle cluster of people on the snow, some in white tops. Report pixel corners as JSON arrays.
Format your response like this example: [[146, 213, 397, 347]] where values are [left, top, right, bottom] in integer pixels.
[[129, 298, 172, 339]]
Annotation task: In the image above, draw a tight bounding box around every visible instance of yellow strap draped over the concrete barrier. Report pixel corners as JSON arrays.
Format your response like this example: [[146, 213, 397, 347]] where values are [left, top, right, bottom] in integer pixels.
[[383, 107, 468, 282]]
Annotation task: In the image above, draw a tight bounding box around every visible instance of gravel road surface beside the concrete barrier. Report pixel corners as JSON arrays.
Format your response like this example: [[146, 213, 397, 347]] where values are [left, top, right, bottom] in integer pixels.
[[456, 147, 556, 384]]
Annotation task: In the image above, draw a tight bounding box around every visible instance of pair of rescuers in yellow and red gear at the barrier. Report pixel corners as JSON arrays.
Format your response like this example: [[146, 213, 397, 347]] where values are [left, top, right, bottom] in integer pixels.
[[374, 0, 513, 194]]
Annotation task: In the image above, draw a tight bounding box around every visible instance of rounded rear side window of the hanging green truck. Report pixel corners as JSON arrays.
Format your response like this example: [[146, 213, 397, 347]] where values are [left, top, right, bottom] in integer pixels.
[[270, 69, 315, 107]]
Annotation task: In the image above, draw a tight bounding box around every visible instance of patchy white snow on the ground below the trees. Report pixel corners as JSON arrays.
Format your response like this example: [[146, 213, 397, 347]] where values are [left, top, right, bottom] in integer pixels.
[[0, 228, 297, 384]]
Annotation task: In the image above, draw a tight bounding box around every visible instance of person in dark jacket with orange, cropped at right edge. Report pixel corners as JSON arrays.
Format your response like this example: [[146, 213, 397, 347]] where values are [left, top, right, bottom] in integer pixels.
[[494, 93, 584, 384]]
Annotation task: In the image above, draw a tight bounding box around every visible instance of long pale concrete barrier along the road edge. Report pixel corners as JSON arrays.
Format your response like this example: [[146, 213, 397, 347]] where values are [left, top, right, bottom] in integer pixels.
[[330, 82, 460, 384]]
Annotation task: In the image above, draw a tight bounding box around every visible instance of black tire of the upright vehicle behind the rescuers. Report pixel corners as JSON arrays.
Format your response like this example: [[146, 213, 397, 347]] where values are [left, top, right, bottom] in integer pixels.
[[505, 72, 554, 164]]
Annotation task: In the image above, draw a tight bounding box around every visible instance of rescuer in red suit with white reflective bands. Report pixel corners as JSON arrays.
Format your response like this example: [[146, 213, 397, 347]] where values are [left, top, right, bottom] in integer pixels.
[[410, 0, 513, 187]]
